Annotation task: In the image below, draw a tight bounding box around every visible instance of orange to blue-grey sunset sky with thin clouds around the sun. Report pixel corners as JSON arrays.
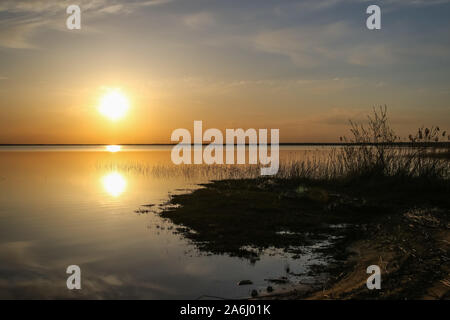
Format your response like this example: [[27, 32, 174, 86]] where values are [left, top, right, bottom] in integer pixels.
[[0, 0, 450, 144]]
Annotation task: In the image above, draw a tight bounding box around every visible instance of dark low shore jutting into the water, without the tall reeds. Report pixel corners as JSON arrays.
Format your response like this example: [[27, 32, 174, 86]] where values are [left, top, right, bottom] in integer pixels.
[[160, 178, 450, 299]]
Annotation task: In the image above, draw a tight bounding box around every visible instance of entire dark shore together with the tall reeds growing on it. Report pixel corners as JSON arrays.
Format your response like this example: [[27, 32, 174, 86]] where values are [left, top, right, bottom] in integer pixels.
[[153, 108, 450, 298]]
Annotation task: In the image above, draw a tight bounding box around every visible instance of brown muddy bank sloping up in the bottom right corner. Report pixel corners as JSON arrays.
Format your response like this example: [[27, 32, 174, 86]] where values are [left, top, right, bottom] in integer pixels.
[[268, 209, 450, 299]]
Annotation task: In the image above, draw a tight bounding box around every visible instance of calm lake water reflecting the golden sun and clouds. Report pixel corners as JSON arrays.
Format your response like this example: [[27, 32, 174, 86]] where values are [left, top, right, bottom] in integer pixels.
[[0, 146, 330, 299]]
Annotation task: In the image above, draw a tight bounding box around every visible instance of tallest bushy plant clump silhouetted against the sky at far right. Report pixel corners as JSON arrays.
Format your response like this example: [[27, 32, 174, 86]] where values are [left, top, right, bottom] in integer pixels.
[[338, 106, 449, 179]]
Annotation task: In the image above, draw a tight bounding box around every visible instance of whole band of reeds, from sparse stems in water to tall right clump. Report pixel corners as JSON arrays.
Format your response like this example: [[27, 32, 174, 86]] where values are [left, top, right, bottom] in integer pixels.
[[99, 107, 450, 183]]
